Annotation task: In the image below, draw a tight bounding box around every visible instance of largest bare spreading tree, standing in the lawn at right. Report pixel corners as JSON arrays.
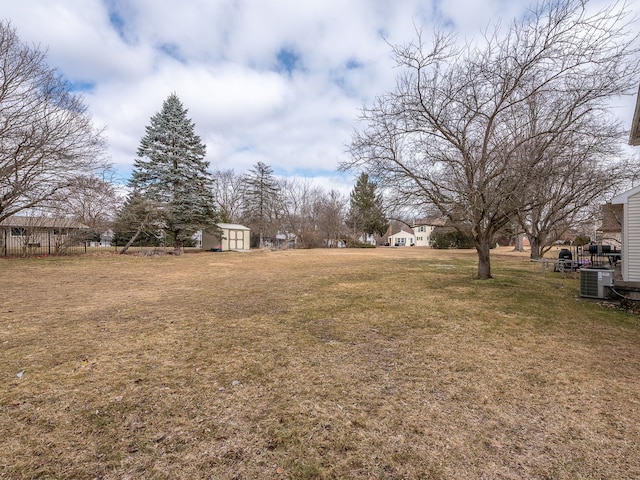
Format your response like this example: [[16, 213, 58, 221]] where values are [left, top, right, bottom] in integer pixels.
[[343, 0, 639, 279]]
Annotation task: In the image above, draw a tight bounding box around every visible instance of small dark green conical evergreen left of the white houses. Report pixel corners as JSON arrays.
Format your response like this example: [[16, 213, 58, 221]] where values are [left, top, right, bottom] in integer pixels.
[[347, 172, 389, 241]]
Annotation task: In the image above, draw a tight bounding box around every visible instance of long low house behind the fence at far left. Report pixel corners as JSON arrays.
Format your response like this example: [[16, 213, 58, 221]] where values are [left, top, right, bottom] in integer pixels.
[[0, 215, 90, 255]]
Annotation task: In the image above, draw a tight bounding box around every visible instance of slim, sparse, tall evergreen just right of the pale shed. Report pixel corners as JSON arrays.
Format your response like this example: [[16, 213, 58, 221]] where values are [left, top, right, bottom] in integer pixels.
[[244, 162, 279, 248]]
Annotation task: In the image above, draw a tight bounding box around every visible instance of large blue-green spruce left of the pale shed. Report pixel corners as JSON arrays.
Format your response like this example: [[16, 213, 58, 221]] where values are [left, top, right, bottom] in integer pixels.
[[129, 93, 217, 251]]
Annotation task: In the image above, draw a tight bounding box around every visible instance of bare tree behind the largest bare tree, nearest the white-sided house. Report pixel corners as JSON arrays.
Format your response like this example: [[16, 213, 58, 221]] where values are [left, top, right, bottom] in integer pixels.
[[516, 87, 627, 259]]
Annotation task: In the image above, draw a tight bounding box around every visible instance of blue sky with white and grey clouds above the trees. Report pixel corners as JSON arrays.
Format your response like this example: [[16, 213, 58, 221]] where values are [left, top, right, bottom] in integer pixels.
[[0, 0, 640, 193]]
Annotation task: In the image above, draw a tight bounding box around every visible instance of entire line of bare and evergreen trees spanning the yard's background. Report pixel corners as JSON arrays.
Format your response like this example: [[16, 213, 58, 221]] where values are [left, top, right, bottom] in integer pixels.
[[0, 0, 640, 268]]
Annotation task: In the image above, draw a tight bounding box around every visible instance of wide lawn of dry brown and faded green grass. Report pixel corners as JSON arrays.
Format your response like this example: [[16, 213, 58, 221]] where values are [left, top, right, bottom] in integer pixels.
[[0, 248, 640, 479]]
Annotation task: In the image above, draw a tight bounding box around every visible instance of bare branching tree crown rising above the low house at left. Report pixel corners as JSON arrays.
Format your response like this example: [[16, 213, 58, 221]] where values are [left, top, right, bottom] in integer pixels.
[[0, 22, 106, 221]]
